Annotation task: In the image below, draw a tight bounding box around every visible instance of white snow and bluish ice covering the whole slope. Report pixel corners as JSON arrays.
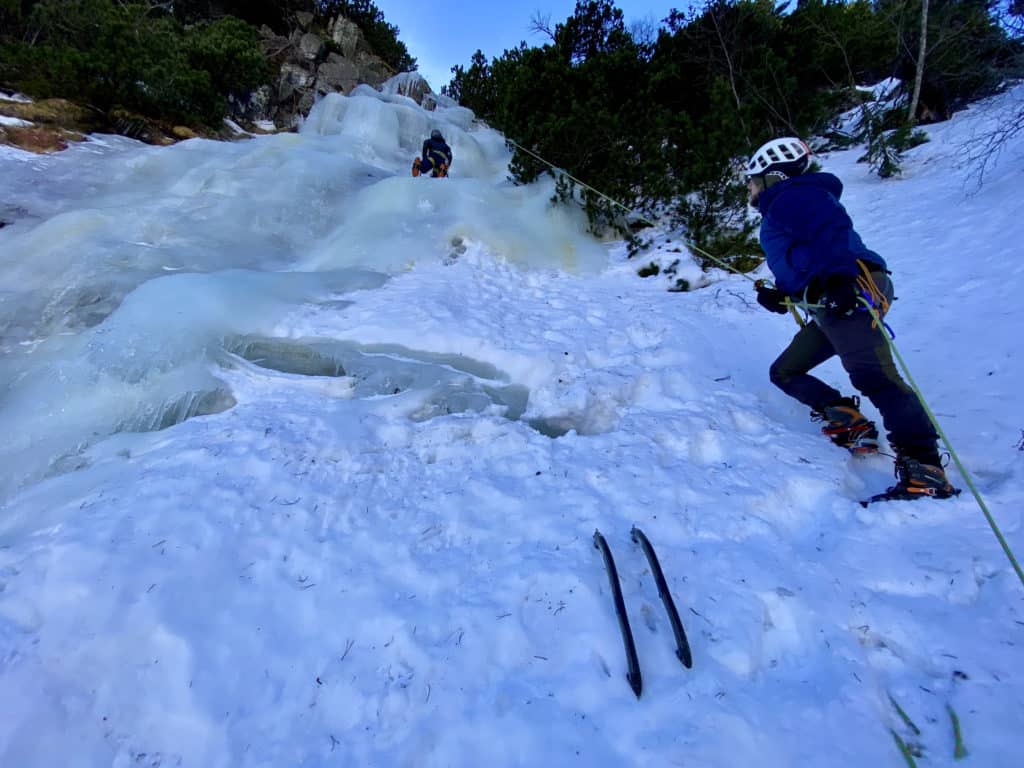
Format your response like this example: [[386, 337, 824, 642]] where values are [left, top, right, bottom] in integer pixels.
[[0, 81, 1024, 768]]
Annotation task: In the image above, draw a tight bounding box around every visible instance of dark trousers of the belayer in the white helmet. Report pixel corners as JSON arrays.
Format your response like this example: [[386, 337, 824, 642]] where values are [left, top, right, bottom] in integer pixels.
[[769, 272, 938, 464]]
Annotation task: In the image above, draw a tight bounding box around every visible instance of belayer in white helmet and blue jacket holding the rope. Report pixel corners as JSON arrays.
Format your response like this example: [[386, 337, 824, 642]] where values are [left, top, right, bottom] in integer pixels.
[[746, 137, 957, 499]]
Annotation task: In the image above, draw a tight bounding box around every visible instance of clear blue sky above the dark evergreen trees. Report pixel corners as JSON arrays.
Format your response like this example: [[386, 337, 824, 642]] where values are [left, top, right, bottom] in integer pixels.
[[376, 0, 689, 91]]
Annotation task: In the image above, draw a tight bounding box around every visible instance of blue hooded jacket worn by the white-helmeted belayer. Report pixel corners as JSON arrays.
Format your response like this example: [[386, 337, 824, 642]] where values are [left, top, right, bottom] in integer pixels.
[[758, 173, 886, 297]]
